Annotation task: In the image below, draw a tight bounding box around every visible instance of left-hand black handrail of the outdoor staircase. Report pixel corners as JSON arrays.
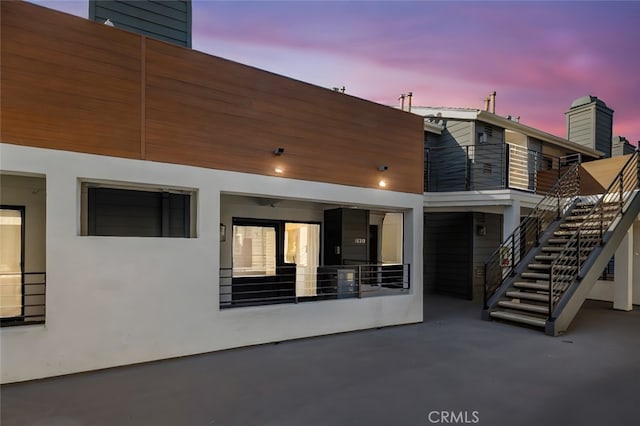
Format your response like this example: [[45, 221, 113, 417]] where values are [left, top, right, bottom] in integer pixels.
[[483, 163, 580, 309]]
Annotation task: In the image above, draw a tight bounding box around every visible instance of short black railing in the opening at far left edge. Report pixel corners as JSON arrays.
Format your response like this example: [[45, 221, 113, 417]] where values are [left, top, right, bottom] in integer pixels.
[[0, 272, 46, 327]]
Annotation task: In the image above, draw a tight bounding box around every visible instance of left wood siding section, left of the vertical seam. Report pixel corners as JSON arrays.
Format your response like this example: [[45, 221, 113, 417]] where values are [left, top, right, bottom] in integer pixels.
[[0, 2, 141, 158]]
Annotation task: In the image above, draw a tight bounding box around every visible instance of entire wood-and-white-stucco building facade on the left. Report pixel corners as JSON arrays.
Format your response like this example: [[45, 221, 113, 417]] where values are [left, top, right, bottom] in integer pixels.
[[0, 2, 423, 383]]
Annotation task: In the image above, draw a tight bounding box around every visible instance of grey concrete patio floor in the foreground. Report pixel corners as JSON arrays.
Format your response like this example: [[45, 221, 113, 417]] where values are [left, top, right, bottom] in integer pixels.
[[0, 295, 640, 426]]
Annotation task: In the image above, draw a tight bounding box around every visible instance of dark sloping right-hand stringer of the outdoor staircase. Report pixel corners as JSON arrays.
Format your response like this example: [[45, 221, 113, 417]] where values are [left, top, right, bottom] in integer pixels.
[[545, 190, 640, 336]]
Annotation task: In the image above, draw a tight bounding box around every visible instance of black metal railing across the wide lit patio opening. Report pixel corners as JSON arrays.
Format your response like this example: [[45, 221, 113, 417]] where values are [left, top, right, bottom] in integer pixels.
[[220, 264, 410, 309]]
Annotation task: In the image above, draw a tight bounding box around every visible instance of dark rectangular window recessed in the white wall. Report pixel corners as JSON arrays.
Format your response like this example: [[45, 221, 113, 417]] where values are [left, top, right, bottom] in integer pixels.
[[87, 187, 191, 238]]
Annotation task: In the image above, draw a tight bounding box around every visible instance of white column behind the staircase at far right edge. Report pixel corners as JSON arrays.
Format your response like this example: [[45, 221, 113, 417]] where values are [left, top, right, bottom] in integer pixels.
[[613, 225, 636, 311]]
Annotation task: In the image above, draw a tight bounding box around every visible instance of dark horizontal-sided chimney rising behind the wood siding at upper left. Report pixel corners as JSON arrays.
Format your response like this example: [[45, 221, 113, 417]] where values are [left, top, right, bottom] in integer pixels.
[[89, 0, 191, 47]]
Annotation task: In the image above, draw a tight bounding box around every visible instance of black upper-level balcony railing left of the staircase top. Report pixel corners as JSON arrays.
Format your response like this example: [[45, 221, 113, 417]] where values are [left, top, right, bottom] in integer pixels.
[[424, 144, 579, 193]]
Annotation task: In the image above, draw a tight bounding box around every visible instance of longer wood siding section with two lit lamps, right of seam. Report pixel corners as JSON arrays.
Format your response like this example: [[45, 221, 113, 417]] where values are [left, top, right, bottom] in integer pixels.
[[145, 40, 423, 193]]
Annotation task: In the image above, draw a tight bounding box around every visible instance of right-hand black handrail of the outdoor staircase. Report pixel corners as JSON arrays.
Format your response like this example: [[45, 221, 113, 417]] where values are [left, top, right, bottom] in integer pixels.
[[549, 150, 640, 319]]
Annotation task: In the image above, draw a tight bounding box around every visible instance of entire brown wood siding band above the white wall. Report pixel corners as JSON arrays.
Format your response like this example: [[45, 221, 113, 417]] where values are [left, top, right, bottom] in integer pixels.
[[0, 2, 424, 193]]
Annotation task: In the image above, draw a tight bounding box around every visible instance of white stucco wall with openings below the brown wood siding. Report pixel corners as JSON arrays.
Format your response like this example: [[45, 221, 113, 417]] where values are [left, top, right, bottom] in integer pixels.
[[0, 144, 423, 383]]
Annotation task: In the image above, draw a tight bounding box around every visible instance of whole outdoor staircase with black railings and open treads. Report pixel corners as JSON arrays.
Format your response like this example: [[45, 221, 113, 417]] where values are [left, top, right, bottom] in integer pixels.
[[483, 152, 640, 336]]
